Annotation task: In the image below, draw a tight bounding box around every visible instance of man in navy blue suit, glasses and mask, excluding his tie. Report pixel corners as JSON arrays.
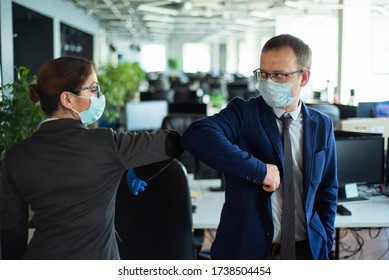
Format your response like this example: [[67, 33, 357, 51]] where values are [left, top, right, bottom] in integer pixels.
[[181, 34, 338, 259]]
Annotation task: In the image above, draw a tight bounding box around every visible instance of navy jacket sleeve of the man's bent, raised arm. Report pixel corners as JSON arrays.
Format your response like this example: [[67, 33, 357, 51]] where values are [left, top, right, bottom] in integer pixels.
[[181, 98, 267, 184]]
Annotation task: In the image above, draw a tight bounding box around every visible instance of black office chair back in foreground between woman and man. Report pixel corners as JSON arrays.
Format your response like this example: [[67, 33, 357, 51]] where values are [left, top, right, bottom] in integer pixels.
[[115, 160, 195, 260]]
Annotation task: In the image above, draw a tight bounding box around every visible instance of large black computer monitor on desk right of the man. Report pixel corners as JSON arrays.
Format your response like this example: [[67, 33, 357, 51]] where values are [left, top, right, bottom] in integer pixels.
[[335, 137, 385, 188]]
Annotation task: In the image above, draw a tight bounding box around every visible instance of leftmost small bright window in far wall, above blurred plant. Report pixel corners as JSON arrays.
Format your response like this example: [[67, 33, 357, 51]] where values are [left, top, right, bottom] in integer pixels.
[[140, 44, 166, 72]]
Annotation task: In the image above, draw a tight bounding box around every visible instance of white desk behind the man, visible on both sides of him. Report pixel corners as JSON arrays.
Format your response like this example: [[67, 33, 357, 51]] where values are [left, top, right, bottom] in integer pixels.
[[188, 174, 389, 259]]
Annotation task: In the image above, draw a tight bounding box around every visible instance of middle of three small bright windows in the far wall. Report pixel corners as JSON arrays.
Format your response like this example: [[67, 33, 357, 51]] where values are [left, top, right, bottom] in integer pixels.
[[183, 43, 211, 73]]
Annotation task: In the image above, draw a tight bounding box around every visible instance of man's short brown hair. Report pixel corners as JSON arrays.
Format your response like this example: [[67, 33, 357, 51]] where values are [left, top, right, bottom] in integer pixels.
[[262, 34, 312, 70]]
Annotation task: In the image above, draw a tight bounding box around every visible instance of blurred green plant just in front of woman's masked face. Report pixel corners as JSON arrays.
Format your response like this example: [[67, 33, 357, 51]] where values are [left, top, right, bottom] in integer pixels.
[[97, 62, 146, 123]]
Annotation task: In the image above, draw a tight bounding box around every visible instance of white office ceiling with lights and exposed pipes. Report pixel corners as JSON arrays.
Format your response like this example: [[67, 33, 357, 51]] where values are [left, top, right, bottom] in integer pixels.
[[65, 0, 389, 42]]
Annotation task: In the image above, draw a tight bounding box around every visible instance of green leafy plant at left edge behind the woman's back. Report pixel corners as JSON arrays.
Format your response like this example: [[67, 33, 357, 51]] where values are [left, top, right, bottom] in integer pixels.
[[0, 66, 44, 159]]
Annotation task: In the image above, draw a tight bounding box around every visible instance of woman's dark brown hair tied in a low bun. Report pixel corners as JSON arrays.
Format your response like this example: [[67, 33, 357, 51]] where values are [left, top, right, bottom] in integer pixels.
[[28, 56, 94, 116]]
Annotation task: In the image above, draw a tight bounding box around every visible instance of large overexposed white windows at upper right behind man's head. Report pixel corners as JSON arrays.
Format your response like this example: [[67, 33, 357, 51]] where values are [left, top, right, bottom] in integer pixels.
[[276, 0, 389, 104]]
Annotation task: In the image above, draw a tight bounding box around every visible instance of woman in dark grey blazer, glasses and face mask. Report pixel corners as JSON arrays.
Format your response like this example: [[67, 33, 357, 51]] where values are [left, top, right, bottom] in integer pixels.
[[0, 57, 182, 259]]
